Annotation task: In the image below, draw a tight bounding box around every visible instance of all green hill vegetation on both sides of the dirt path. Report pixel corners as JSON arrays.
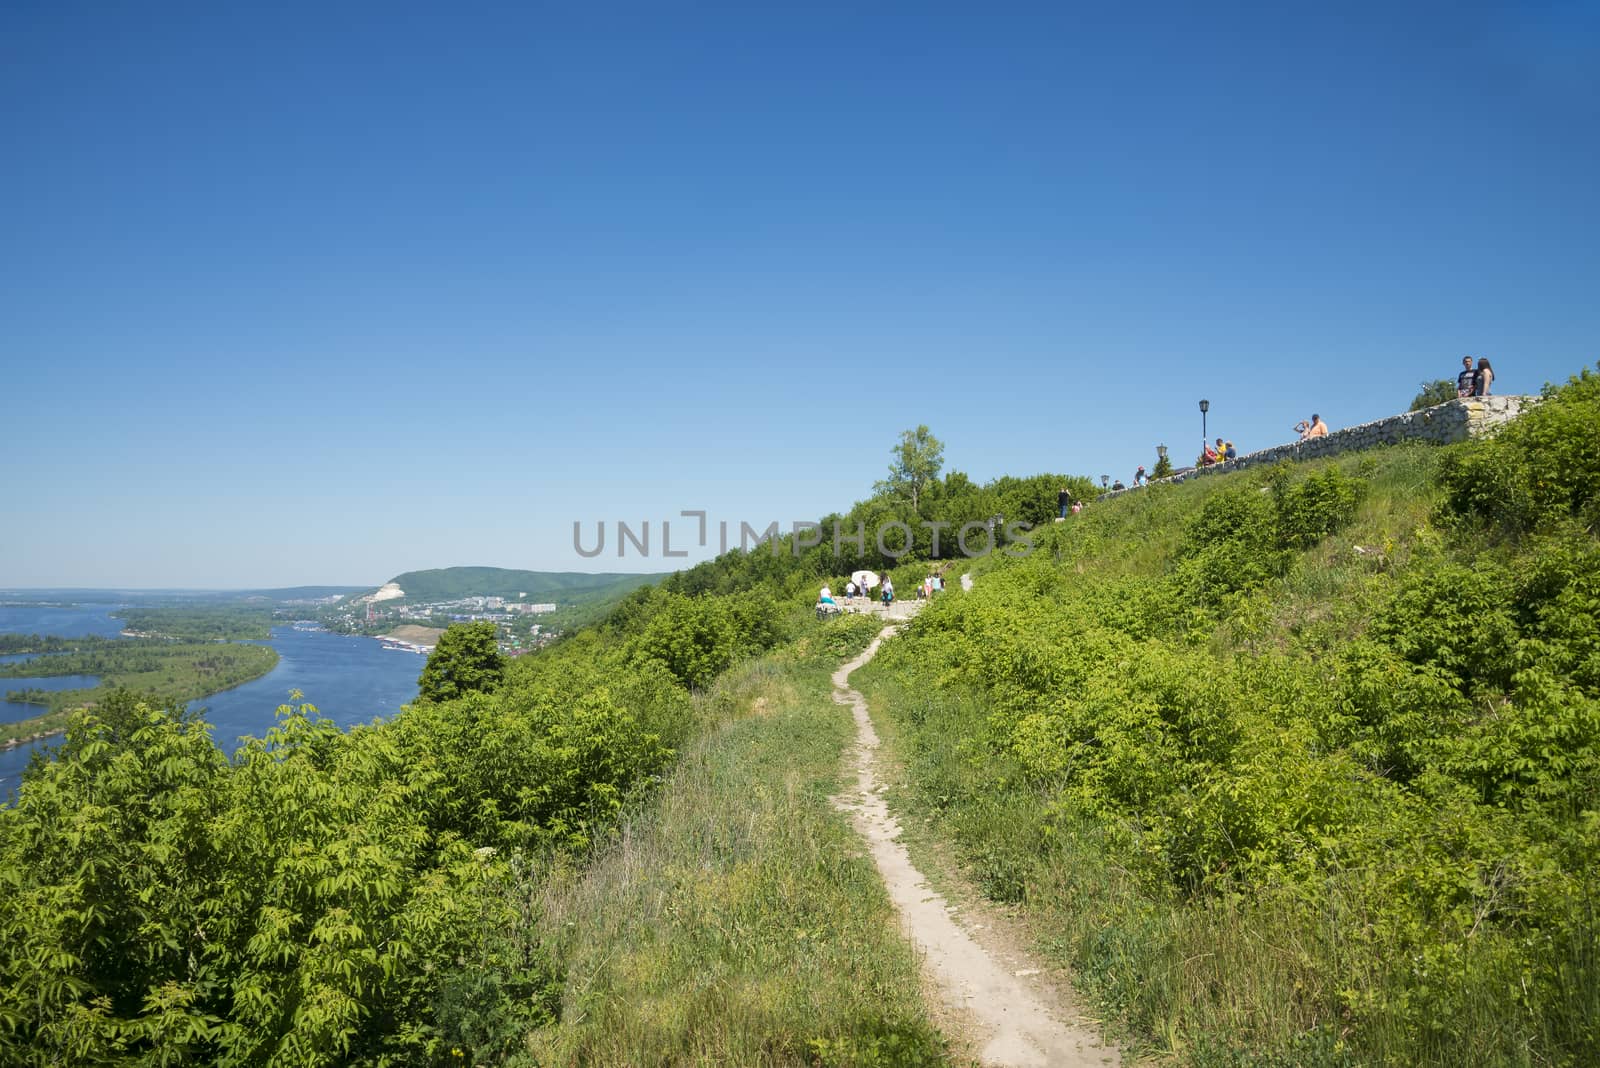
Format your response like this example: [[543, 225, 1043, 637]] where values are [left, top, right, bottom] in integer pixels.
[[0, 371, 1600, 1068]]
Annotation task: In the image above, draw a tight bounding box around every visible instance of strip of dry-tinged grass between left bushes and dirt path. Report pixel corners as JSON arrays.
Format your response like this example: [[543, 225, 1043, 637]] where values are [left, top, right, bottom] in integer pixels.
[[528, 628, 947, 1065]]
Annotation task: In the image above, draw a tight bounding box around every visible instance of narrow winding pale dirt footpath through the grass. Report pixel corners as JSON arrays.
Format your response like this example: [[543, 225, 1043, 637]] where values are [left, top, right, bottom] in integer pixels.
[[834, 627, 1120, 1068]]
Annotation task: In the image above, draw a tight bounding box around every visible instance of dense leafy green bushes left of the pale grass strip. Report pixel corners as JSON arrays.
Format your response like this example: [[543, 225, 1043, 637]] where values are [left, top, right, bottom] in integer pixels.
[[0, 578, 789, 1065]]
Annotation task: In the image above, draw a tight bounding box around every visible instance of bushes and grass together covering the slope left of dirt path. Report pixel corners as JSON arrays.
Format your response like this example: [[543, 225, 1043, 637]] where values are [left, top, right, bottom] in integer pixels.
[[0, 562, 944, 1066]]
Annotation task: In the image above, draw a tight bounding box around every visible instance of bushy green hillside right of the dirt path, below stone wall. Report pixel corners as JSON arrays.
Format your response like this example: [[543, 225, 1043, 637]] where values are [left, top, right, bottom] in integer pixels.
[[858, 364, 1600, 1065]]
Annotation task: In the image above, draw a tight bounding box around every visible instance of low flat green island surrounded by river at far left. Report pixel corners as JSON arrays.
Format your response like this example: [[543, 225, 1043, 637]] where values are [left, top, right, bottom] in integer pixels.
[[0, 638, 278, 745]]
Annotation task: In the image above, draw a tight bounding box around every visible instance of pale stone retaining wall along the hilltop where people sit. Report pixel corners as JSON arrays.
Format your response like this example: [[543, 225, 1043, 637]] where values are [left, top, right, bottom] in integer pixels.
[[1096, 397, 1539, 500]]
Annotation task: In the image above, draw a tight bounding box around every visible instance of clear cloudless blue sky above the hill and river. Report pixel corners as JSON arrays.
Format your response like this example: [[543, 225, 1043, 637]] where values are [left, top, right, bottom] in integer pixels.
[[0, 0, 1600, 587]]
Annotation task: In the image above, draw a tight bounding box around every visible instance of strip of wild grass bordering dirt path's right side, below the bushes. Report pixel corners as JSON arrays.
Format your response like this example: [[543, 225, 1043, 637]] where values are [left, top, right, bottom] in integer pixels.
[[853, 667, 1600, 1068]]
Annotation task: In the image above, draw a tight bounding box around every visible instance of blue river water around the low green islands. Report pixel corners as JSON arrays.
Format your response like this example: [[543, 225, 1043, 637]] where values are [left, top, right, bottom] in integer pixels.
[[0, 604, 426, 799]]
